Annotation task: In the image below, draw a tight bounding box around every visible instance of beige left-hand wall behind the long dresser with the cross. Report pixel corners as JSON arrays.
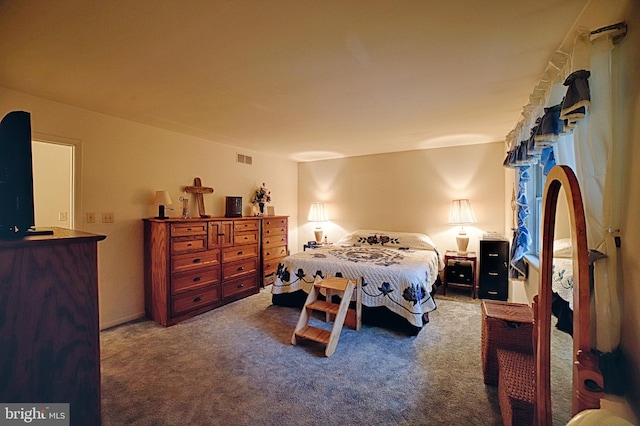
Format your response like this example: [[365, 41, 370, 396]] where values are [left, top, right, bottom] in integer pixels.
[[0, 89, 298, 328]]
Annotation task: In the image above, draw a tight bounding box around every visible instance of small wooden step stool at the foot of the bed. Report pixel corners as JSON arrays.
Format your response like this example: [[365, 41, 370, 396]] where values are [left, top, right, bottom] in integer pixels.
[[291, 277, 362, 356]]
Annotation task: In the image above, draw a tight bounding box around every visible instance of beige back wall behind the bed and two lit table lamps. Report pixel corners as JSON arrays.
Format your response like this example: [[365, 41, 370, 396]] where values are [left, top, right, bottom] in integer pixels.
[[298, 142, 505, 253]]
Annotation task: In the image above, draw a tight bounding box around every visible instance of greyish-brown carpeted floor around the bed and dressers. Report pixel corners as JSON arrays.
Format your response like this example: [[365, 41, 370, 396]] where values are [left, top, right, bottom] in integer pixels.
[[101, 288, 571, 425]]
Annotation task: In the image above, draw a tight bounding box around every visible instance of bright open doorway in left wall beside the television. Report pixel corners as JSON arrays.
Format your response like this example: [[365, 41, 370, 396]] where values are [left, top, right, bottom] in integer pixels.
[[32, 140, 76, 229]]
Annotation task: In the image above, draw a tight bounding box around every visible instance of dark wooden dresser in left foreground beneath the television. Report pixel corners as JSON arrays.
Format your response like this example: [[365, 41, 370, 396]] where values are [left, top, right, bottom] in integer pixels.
[[0, 228, 105, 425]]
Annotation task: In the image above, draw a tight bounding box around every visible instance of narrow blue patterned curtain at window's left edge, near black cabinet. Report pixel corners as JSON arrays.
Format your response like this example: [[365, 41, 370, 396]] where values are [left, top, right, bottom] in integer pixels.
[[509, 165, 531, 278]]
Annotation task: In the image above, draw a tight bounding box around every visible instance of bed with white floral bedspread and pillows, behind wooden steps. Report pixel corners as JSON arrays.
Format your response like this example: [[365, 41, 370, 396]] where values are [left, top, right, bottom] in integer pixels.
[[271, 230, 444, 332]]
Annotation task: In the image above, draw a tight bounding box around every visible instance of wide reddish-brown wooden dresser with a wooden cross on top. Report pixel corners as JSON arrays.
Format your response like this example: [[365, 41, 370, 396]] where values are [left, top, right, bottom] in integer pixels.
[[143, 217, 261, 327]]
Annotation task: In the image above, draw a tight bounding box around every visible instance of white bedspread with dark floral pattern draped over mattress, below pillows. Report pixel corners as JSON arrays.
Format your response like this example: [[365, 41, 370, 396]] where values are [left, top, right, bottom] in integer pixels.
[[271, 246, 440, 327]]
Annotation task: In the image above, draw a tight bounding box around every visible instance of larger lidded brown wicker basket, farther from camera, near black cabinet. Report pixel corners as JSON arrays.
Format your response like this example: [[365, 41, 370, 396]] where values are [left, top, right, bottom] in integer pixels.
[[481, 300, 533, 385]]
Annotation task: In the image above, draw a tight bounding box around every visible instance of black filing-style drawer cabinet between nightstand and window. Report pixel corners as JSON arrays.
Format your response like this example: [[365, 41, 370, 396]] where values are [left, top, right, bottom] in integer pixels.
[[479, 240, 509, 301]]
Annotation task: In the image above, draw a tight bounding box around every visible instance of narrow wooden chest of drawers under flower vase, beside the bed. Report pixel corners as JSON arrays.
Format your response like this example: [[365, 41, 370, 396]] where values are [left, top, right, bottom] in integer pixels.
[[262, 216, 289, 286]]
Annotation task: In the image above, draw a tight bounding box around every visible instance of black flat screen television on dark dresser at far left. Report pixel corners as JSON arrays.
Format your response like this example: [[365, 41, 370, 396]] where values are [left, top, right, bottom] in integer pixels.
[[0, 111, 35, 238]]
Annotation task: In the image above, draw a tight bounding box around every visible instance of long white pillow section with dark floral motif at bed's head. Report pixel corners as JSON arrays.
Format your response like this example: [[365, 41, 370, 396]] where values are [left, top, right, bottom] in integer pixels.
[[335, 229, 437, 250]]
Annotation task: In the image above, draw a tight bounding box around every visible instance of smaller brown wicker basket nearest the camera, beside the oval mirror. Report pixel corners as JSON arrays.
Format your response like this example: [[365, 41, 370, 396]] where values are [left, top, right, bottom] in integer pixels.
[[496, 349, 536, 426]]
